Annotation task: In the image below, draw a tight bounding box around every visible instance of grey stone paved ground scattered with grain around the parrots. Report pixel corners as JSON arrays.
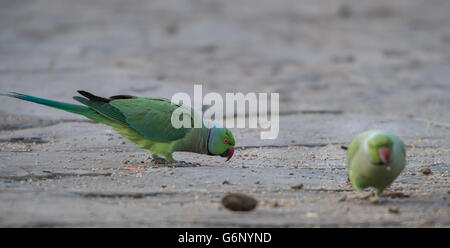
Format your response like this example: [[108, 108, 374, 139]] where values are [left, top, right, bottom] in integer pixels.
[[0, 0, 450, 227]]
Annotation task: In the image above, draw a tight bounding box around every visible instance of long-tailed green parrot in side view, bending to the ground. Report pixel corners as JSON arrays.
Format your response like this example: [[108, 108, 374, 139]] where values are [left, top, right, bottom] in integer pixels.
[[1, 91, 235, 162]]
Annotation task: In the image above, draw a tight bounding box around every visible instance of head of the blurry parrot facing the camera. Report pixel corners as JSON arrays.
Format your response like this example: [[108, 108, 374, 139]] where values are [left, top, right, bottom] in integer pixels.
[[366, 133, 394, 165]]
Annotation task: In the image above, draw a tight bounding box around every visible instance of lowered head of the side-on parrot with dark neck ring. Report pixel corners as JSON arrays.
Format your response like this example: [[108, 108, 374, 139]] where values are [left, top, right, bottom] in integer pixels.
[[206, 126, 235, 161]]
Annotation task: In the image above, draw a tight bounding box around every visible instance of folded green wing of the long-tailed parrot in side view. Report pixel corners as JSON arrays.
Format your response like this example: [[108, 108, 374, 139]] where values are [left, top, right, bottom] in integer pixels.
[[109, 97, 194, 142]]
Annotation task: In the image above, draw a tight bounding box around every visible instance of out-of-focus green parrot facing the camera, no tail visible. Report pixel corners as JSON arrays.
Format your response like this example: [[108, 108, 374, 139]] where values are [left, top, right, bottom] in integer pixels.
[[347, 130, 406, 196]]
